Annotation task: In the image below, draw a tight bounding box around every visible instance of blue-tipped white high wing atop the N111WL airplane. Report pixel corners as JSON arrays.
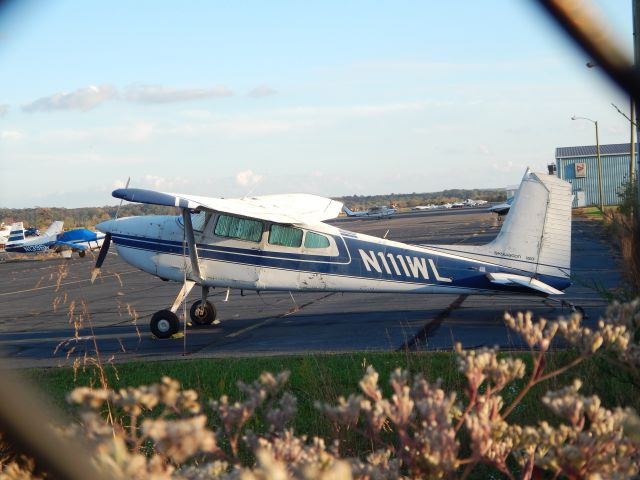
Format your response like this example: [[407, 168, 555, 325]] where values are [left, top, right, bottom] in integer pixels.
[[112, 188, 342, 224]]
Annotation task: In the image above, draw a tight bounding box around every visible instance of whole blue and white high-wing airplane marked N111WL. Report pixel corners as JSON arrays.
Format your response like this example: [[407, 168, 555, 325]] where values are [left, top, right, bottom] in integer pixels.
[[92, 170, 571, 338]]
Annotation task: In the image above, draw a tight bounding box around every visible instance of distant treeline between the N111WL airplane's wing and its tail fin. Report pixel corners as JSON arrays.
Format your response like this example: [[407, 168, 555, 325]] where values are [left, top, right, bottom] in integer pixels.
[[336, 188, 507, 210]]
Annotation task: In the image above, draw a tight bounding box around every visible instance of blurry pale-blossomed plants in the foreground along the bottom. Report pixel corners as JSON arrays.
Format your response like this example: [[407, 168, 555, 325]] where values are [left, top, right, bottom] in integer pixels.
[[2, 301, 640, 479]]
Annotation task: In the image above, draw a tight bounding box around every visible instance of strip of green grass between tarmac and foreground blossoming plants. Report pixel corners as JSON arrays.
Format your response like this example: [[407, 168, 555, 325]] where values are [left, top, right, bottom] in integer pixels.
[[26, 351, 640, 437]]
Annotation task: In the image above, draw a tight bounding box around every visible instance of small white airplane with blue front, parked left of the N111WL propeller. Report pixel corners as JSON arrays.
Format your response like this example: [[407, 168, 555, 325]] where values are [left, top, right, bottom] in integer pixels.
[[5, 221, 105, 258]]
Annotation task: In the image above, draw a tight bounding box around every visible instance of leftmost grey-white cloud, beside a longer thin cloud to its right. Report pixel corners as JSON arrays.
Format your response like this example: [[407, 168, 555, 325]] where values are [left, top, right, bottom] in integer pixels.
[[22, 85, 118, 113]]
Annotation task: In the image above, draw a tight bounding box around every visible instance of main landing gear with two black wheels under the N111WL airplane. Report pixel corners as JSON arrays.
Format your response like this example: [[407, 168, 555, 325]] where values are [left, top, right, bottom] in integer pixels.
[[150, 280, 220, 339]]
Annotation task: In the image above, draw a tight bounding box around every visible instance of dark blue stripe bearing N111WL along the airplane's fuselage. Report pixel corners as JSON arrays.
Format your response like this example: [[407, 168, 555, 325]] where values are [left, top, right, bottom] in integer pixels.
[[112, 233, 570, 293]]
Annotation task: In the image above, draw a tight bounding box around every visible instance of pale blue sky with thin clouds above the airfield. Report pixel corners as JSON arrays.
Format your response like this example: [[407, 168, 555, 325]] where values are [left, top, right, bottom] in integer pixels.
[[0, 0, 632, 208]]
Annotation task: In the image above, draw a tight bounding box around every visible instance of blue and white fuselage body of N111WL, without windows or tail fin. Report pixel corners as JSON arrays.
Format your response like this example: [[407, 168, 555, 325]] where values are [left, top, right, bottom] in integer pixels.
[[103, 215, 570, 294]]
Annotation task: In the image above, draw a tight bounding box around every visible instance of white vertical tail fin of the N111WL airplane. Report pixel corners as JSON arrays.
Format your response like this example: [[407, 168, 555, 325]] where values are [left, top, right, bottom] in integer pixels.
[[436, 170, 572, 278]]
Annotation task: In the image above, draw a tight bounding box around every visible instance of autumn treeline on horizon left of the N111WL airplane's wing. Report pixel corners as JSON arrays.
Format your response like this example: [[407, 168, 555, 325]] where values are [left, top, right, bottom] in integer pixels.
[[0, 204, 176, 229]]
